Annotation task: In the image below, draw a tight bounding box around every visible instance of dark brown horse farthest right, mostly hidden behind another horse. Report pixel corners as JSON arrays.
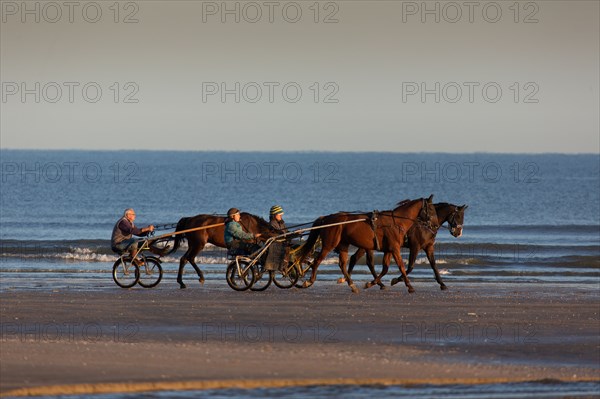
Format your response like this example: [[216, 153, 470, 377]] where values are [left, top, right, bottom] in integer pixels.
[[338, 202, 468, 290]]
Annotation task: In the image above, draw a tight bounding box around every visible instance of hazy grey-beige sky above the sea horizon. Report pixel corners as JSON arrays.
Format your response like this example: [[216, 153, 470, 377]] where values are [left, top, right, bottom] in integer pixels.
[[0, 0, 600, 153]]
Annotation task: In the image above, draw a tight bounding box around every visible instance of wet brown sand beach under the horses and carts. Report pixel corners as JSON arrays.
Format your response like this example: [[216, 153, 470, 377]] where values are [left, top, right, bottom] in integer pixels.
[[0, 281, 600, 395]]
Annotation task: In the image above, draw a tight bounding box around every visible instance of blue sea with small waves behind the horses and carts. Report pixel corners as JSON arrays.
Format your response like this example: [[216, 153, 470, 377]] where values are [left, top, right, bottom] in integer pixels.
[[0, 150, 600, 290]]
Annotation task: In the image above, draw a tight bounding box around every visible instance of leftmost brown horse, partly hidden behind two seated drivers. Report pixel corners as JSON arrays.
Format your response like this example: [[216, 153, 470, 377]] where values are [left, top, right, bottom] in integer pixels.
[[151, 212, 277, 288]]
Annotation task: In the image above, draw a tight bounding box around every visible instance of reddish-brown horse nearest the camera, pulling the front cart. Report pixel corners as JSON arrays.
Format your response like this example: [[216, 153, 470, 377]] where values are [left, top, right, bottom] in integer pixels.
[[299, 195, 437, 292]]
